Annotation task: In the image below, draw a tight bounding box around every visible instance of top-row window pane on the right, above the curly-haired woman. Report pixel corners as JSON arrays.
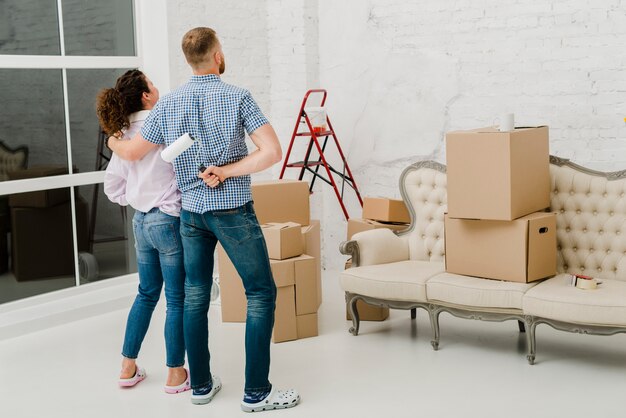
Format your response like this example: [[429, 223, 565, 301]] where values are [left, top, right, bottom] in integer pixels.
[[62, 0, 135, 56]]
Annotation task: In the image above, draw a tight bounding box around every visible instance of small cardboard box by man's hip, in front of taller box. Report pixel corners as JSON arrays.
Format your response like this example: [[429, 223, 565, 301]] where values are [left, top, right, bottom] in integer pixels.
[[261, 222, 304, 260]]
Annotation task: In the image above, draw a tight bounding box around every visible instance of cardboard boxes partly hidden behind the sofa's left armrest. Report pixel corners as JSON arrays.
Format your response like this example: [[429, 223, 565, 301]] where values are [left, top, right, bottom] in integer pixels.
[[346, 197, 411, 321]]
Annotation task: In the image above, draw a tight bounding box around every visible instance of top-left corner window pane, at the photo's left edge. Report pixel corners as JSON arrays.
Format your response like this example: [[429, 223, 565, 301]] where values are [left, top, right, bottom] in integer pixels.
[[0, 0, 61, 55]]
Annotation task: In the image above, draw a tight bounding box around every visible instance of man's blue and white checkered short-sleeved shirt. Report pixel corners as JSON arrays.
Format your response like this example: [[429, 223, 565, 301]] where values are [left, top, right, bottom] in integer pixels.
[[141, 74, 268, 213]]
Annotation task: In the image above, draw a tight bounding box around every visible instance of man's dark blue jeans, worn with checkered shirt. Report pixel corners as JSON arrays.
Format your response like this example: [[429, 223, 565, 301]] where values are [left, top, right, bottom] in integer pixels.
[[180, 202, 276, 392]]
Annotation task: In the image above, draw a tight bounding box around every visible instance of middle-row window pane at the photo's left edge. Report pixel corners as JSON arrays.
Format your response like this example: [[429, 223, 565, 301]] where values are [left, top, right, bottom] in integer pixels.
[[0, 69, 67, 167]]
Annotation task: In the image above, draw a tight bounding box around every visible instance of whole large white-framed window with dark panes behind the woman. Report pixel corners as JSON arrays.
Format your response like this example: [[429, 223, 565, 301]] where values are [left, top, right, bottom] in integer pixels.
[[0, 0, 146, 303]]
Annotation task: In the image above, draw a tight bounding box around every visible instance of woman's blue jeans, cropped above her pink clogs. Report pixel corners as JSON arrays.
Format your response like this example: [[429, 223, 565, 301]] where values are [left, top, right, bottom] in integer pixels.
[[122, 208, 185, 367]]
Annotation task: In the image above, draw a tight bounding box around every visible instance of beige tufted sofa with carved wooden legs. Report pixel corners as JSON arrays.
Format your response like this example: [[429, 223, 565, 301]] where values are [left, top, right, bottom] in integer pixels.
[[340, 156, 626, 364]]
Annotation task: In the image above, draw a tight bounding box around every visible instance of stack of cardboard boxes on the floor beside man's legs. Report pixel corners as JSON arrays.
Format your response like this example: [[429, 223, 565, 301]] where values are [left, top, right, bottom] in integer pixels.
[[218, 180, 322, 343]]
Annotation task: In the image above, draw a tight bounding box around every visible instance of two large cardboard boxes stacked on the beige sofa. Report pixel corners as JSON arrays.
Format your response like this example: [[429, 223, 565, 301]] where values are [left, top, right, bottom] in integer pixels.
[[445, 126, 556, 283]]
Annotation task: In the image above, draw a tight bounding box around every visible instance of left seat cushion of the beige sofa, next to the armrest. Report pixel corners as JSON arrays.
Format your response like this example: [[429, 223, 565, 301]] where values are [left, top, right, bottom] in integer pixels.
[[340, 261, 445, 302]]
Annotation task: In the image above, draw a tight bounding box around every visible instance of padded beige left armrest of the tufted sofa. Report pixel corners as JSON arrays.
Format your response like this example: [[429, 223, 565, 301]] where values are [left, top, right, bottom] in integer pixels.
[[339, 229, 409, 267]]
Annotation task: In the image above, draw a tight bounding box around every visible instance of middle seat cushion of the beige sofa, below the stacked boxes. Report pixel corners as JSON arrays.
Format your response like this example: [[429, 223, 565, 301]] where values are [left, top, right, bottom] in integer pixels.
[[426, 273, 537, 309]]
